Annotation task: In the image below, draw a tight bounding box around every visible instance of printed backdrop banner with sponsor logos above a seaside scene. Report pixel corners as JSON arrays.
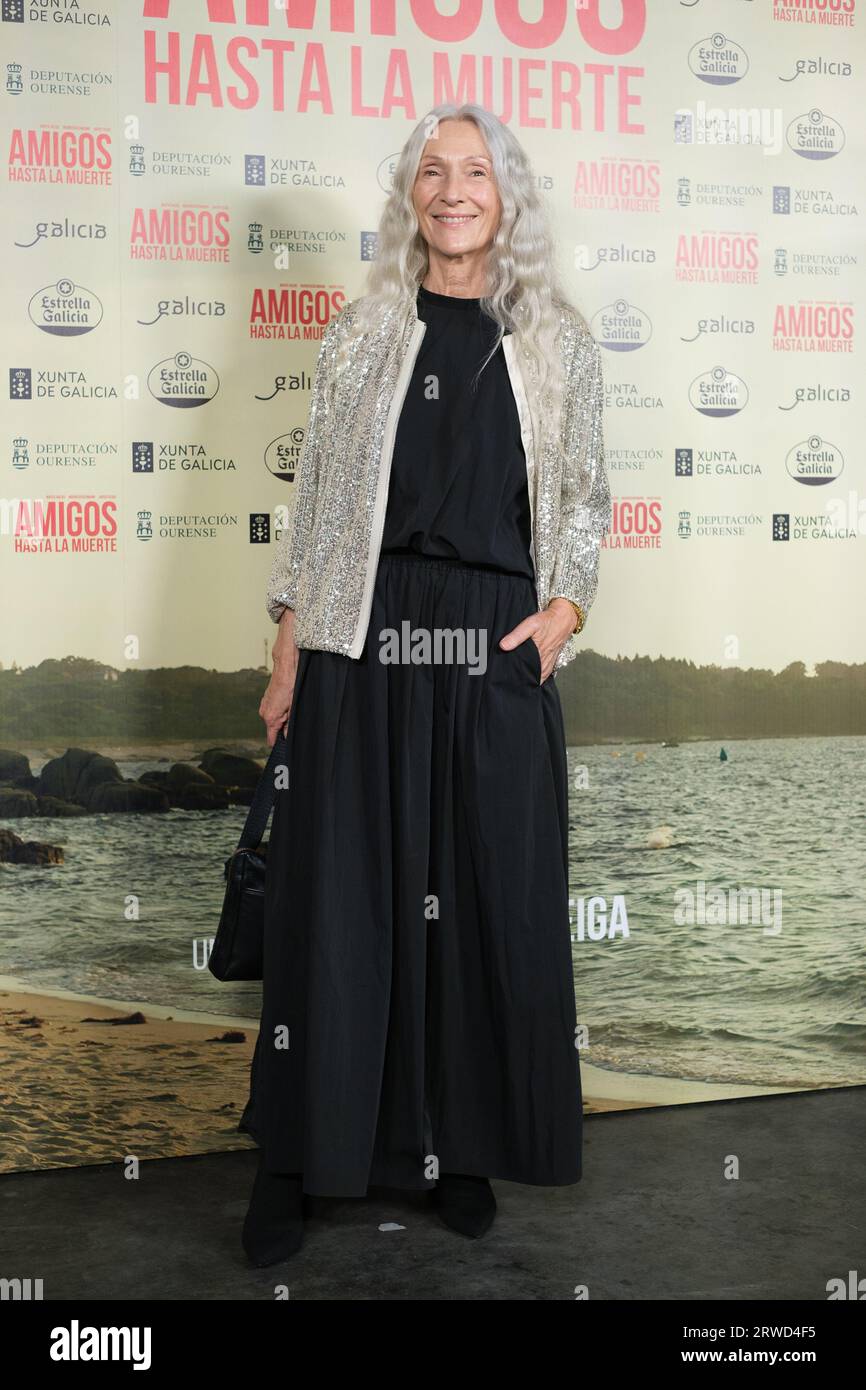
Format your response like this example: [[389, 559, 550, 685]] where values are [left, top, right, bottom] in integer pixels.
[[0, 0, 866, 1169]]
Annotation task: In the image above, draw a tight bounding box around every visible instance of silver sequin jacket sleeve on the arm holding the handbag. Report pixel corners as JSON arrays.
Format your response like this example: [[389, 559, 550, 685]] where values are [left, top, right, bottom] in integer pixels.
[[267, 314, 339, 623]]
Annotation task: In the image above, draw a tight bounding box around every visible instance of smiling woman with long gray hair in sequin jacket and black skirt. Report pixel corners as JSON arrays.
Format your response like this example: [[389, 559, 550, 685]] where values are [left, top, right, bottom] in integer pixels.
[[240, 106, 610, 1265]]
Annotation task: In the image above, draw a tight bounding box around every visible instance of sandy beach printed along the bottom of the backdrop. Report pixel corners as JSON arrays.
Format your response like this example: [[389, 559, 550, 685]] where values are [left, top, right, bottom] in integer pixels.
[[0, 977, 800, 1172]]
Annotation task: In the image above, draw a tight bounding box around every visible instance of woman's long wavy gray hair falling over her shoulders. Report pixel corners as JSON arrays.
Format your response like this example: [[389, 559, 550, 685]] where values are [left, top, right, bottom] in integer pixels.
[[335, 103, 582, 461]]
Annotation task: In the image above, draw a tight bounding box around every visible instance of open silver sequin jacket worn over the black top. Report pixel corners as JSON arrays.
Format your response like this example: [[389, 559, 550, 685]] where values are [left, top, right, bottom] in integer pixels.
[[267, 290, 610, 669]]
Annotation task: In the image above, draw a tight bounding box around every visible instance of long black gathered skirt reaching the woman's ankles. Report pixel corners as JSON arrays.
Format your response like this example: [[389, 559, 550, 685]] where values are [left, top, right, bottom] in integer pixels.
[[239, 555, 582, 1197]]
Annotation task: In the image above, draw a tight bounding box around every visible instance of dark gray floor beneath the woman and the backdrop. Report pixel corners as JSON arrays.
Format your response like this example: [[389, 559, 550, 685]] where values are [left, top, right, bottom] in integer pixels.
[[0, 1087, 866, 1301]]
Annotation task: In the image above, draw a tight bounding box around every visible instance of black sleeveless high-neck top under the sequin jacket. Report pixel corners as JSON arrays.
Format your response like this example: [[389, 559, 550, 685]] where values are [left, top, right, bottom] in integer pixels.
[[382, 286, 535, 580]]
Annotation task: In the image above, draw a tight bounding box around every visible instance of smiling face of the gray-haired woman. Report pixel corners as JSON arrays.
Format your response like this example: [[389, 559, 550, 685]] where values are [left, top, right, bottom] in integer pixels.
[[413, 120, 502, 260]]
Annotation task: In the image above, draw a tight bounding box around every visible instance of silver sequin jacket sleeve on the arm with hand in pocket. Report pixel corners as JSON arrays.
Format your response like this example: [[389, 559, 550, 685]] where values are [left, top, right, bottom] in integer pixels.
[[549, 324, 612, 636]]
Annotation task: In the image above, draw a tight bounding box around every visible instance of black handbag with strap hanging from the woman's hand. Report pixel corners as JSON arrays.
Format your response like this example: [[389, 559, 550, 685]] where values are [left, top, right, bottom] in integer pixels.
[[207, 730, 288, 980]]
